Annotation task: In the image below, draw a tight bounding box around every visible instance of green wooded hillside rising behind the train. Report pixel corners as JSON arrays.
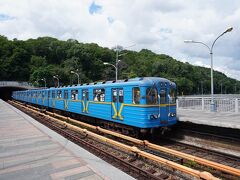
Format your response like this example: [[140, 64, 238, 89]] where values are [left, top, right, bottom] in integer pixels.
[[0, 36, 240, 95]]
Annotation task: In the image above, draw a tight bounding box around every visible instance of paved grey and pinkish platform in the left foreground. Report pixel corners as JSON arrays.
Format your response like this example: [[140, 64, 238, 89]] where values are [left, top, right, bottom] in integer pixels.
[[0, 99, 134, 180]]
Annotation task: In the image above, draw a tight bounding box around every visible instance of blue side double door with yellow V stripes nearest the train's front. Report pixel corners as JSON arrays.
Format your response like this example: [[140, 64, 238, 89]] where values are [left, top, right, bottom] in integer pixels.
[[112, 88, 124, 120]]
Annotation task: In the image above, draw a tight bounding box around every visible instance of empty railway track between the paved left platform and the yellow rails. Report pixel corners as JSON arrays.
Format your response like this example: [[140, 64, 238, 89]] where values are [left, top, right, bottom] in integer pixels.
[[8, 100, 197, 179]]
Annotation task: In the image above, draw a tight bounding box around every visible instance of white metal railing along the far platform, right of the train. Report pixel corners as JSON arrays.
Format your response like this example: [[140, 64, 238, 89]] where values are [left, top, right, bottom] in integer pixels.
[[177, 96, 240, 113]]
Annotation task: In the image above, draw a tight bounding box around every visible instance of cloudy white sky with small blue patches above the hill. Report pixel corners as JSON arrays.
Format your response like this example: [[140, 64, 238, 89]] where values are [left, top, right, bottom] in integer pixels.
[[0, 0, 240, 80]]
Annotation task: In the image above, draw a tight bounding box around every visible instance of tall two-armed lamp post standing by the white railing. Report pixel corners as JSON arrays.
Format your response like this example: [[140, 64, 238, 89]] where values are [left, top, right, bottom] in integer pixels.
[[184, 27, 233, 112]]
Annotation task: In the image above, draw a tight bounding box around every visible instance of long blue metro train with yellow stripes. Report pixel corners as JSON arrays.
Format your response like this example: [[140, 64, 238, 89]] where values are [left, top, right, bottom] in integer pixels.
[[12, 77, 176, 133]]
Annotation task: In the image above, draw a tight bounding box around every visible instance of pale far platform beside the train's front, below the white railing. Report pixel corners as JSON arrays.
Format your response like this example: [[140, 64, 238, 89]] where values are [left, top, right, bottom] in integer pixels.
[[177, 109, 240, 129]]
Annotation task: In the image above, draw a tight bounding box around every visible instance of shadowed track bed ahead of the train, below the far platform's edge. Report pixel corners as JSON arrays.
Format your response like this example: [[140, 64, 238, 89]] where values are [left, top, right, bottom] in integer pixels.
[[165, 122, 240, 157]]
